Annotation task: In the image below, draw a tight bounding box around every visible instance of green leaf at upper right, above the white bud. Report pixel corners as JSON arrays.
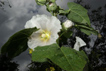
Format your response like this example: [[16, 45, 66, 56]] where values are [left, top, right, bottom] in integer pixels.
[[67, 2, 90, 26]]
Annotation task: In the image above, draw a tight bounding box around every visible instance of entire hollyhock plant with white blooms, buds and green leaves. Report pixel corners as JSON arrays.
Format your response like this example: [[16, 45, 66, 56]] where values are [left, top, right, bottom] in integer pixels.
[[0, 0, 101, 71]]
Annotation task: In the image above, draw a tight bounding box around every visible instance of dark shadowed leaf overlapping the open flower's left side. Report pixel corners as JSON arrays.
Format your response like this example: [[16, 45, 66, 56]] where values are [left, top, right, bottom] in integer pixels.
[[1, 28, 38, 58]]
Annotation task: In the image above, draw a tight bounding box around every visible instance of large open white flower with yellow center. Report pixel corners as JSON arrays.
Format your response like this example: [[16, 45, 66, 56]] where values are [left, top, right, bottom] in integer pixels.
[[25, 15, 61, 50]]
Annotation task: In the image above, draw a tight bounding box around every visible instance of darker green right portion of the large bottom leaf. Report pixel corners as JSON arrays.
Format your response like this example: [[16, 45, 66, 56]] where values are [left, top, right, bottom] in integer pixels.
[[50, 47, 87, 71]]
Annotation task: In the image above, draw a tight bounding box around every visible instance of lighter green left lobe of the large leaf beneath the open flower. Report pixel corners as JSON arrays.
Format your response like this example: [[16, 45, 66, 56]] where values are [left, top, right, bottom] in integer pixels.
[[32, 44, 59, 62]]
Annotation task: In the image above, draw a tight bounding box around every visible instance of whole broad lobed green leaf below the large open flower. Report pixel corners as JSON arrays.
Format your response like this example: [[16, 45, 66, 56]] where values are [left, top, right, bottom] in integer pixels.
[[32, 44, 87, 71]]
